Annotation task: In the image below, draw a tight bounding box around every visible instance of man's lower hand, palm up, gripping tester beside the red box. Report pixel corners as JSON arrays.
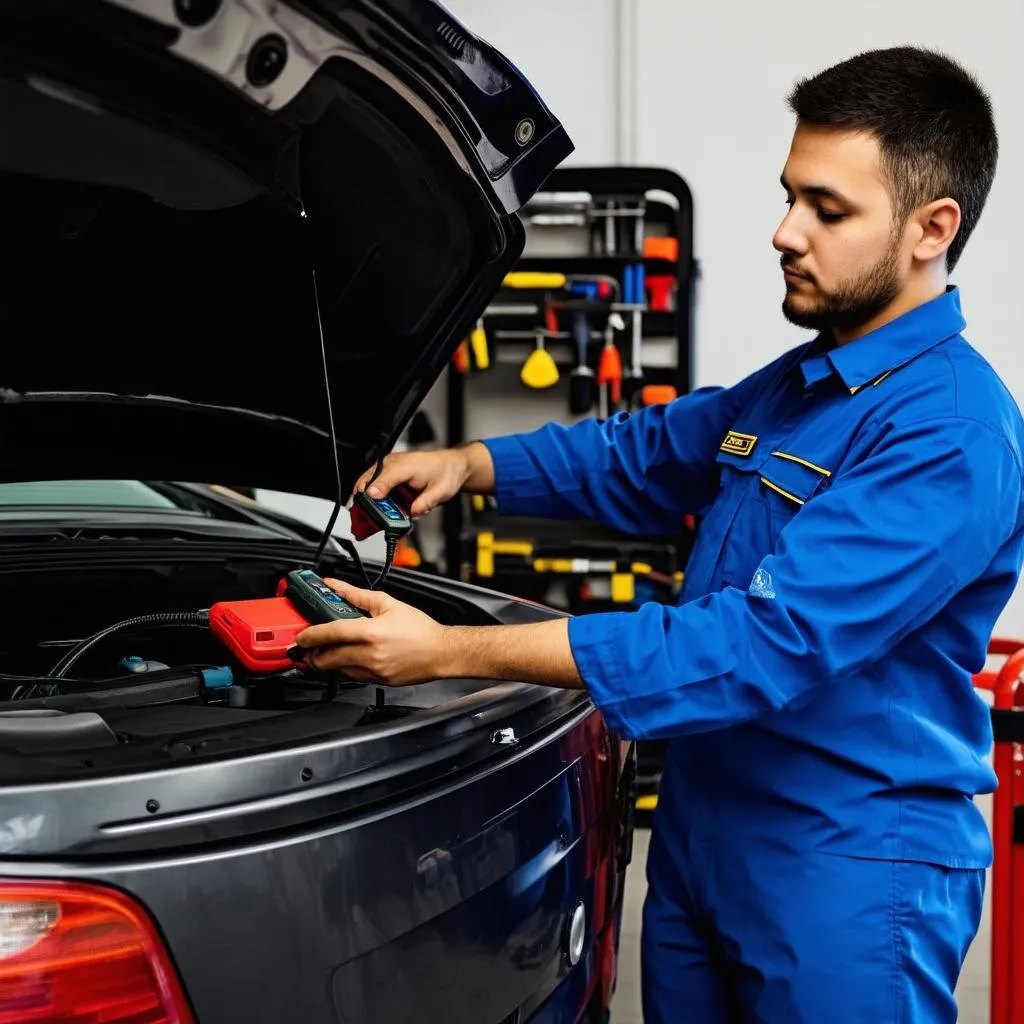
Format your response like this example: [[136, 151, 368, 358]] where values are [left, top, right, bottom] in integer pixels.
[[295, 580, 450, 686]]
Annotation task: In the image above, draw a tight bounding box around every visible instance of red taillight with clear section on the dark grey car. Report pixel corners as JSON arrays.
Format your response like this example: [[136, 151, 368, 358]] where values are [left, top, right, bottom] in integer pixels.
[[0, 880, 195, 1024]]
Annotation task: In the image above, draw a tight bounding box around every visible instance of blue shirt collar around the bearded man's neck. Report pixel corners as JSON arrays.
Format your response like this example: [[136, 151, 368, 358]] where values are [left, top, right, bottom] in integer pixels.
[[800, 285, 967, 394]]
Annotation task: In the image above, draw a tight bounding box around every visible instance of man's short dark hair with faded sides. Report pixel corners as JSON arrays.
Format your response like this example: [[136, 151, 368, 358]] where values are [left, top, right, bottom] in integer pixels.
[[788, 46, 998, 270]]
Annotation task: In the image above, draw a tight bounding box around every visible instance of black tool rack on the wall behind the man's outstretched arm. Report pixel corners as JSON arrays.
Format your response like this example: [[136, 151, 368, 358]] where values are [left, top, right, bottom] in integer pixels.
[[444, 167, 697, 613]]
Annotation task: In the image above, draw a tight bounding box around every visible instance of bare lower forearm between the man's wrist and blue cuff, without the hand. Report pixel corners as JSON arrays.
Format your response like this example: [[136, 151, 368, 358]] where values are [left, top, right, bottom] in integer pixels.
[[440, 618, 584, 689]]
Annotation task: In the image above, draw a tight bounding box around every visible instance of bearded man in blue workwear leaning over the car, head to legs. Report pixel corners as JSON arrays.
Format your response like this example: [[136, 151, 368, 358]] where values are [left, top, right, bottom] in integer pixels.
[[299, 48, 1024, 1024]]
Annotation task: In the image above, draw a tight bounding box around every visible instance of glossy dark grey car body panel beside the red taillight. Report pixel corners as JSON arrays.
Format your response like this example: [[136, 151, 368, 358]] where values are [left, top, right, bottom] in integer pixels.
[[0, 705, 625, 1024]]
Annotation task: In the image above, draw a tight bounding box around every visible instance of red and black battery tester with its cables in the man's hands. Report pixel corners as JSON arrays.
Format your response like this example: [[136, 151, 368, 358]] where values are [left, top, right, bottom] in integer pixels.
[[209, 271, 413, 673]]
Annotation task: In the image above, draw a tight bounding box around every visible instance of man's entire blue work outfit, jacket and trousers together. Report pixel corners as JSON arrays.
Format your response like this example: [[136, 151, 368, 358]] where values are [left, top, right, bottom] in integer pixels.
[[486, 288, 1024, 1024]]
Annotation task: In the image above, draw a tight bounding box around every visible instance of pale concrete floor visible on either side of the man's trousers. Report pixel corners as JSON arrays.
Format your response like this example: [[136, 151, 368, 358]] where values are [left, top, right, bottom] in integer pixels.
[[611, 800, 991, 1024]]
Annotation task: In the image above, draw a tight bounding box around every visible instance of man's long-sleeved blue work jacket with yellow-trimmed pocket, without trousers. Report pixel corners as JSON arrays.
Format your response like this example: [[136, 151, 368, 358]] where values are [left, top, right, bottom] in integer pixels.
[[486, 288, 1024, 867]]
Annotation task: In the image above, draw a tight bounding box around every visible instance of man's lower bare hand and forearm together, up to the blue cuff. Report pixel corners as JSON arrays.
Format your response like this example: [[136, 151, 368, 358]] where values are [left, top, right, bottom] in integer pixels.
[[295, 580, 583, 689]]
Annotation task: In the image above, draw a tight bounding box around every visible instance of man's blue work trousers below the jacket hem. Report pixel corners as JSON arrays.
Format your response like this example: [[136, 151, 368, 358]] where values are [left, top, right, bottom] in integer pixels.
[[643, 814, 985, 1024]]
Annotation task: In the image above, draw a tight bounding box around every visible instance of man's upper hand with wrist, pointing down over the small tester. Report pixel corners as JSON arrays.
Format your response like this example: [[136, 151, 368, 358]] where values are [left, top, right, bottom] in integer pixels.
[[355, 441, 495, 516]]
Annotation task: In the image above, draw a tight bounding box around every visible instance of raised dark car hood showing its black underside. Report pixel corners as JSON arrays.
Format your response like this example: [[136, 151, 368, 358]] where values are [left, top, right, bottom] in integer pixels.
[[0, 0, 572, 497]]
